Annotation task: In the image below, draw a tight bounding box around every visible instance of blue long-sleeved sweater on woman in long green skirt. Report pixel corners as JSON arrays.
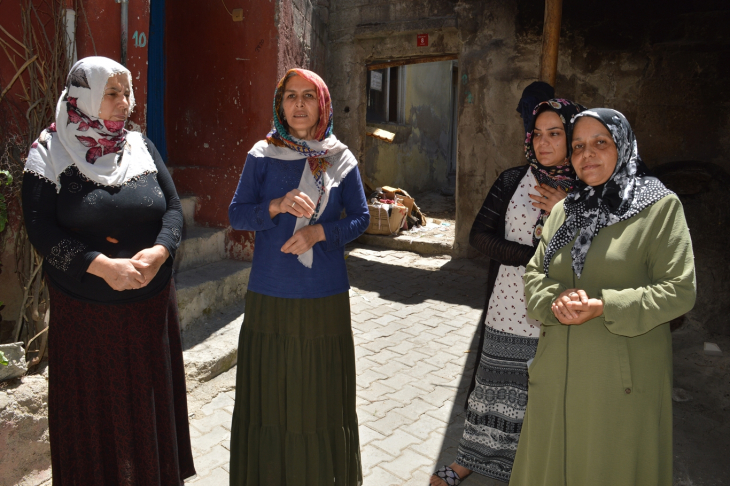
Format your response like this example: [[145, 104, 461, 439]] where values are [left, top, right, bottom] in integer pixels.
[[228, 150, 370, 299]]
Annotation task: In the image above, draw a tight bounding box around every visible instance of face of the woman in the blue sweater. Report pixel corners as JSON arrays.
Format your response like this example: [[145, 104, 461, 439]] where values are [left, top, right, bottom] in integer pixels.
[[281, 76, 319, 140]]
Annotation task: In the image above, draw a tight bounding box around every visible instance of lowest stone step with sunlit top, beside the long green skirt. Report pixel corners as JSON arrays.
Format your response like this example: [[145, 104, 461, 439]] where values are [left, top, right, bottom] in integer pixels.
[[182, 301, 244, 386]]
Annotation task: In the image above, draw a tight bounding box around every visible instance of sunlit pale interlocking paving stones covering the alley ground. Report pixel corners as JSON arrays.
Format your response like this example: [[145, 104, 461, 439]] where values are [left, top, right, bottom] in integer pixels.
[[189, 247, 504, 486]]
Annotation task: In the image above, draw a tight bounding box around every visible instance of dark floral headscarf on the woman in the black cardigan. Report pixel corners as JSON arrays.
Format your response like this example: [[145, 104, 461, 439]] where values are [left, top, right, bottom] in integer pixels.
[[525, 98, 585, 246]]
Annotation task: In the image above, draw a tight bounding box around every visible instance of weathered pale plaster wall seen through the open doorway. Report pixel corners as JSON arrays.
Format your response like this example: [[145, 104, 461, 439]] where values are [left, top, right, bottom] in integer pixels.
[[362, 61, 452, 194]]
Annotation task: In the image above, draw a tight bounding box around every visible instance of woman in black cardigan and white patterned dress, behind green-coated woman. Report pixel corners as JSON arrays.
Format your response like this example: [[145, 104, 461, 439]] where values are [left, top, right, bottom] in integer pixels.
[[431, 99, 584, 486]]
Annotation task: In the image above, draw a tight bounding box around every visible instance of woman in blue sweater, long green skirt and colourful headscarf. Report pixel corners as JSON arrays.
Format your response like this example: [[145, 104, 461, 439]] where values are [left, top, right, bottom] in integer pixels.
[[228, 69, 370, 486]]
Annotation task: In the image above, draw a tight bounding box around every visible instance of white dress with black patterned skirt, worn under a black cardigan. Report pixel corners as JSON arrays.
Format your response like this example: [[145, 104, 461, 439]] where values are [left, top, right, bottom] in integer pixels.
[[456, 170, 540, 482]]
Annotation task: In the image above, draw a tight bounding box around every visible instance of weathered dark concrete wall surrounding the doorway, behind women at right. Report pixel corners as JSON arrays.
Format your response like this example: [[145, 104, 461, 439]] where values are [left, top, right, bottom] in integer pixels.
[[327, 0, 730, 256]]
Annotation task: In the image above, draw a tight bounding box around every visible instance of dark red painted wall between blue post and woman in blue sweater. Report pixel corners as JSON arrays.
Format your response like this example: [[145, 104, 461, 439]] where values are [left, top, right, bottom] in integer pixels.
[[165, 0, 327, 260]]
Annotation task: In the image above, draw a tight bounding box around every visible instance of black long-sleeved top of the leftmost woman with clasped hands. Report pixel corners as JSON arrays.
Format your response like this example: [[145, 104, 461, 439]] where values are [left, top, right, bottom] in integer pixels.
[[22, 138, 183, 304]]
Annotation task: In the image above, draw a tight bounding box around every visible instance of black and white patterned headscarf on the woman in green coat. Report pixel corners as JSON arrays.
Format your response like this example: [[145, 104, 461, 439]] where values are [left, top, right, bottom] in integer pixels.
[[544, 108, 673, 278]]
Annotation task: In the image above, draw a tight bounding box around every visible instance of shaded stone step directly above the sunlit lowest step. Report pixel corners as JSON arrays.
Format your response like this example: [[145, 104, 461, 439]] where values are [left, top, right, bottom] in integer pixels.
[[175, 260, 251, 331]]
